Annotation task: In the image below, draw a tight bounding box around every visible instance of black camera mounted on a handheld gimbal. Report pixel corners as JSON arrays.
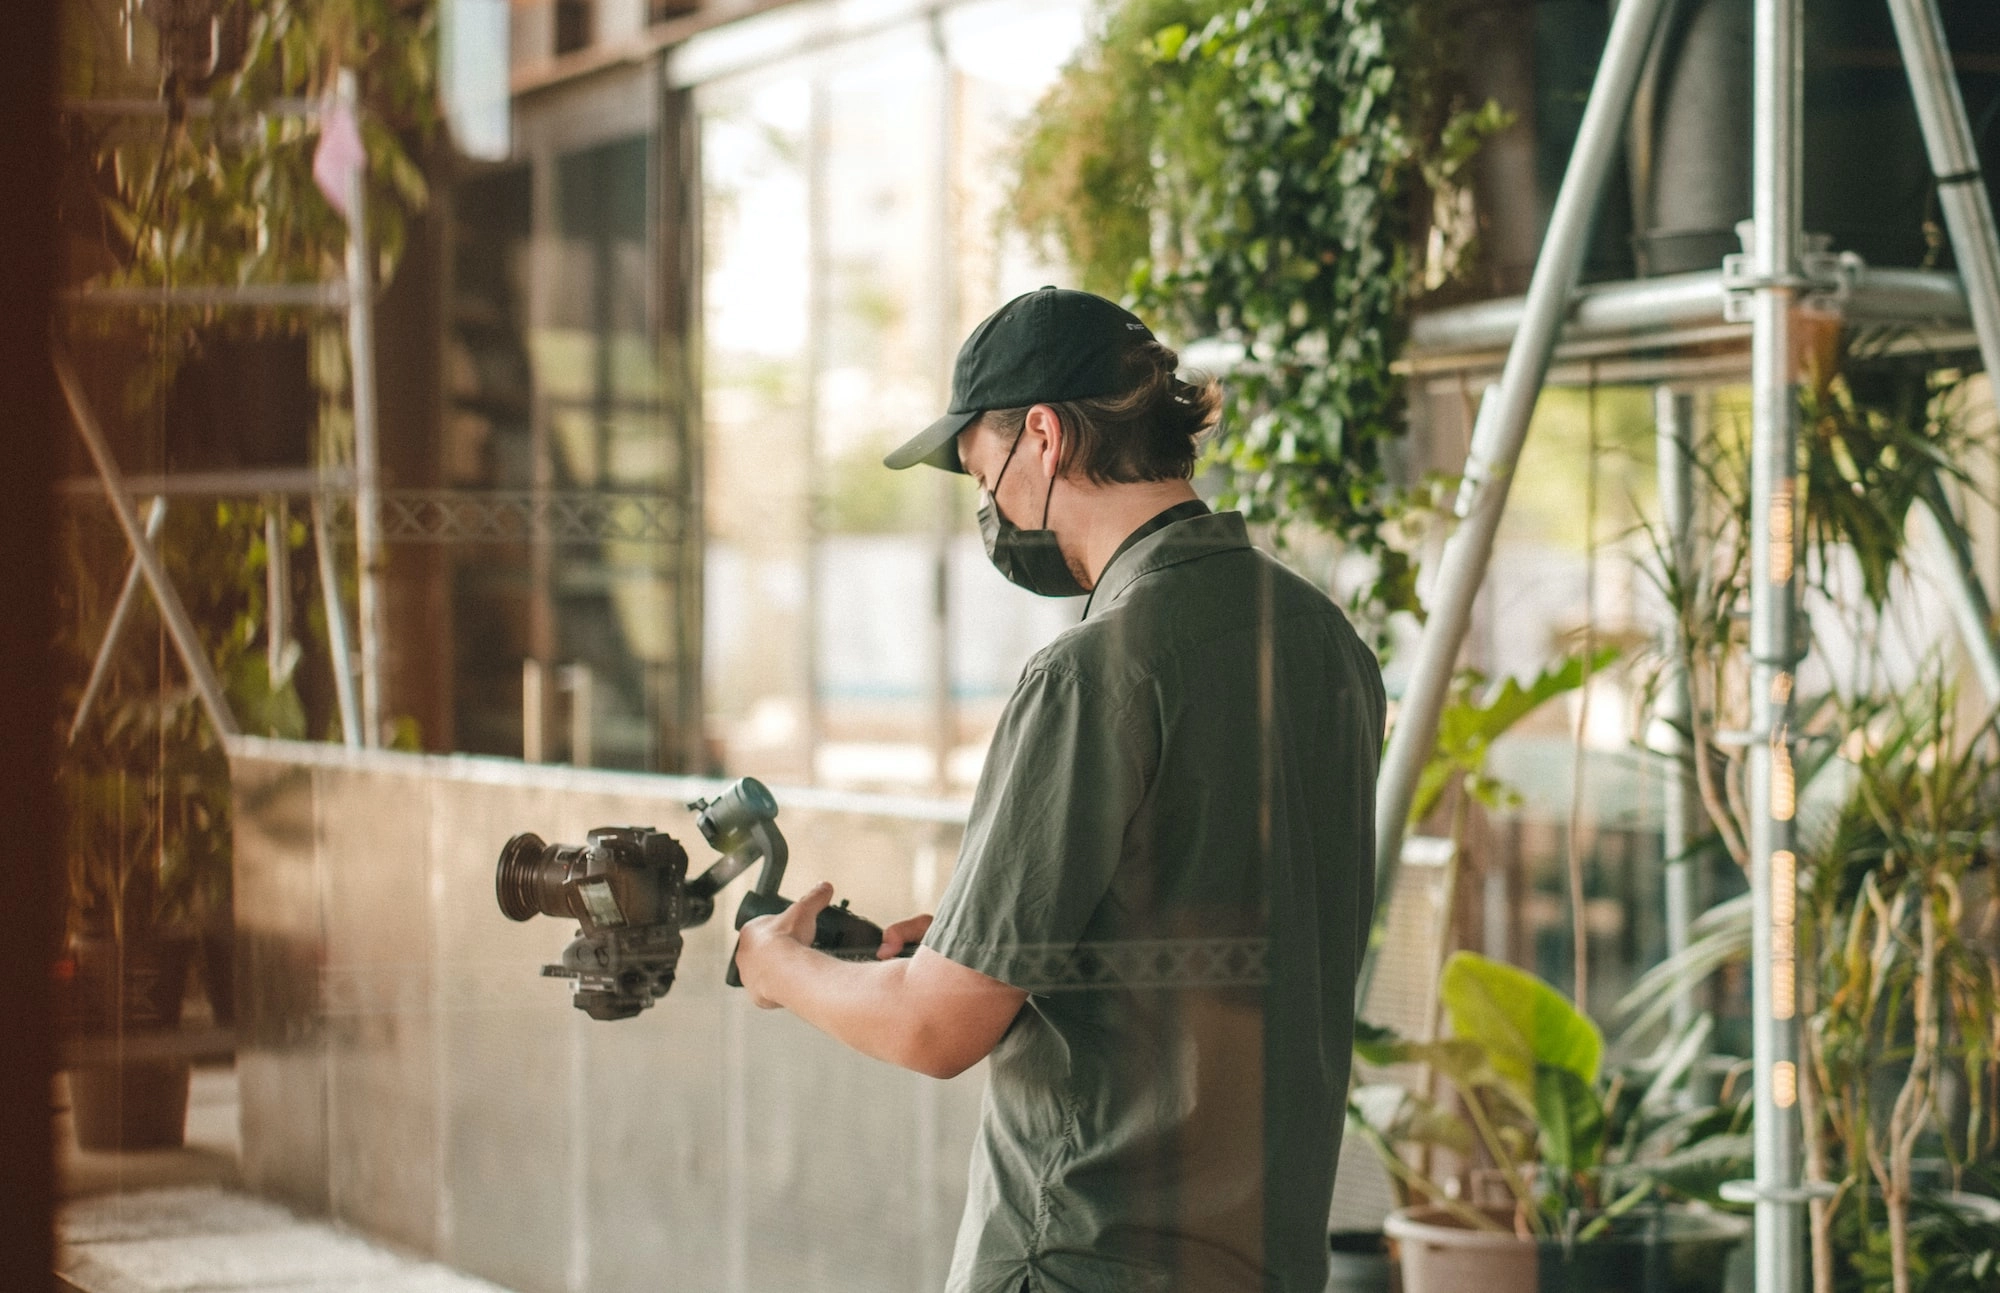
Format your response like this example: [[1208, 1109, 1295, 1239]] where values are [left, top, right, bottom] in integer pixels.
[[494, 777, 914, 1019]]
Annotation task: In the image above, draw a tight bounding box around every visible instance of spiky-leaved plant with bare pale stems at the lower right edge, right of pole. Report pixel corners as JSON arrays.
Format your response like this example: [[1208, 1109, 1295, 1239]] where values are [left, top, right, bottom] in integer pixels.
[[1802, 677, 2000, 1293]]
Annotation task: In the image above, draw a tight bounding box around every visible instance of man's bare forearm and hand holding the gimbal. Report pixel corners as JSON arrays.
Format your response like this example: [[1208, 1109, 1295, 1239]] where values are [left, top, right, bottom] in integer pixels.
[[736, 883, 1028, 1077]]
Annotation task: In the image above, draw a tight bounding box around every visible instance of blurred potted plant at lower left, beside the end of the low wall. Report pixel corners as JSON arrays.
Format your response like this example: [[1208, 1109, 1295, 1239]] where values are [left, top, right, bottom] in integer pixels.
[[58, 506, 304, 1149]]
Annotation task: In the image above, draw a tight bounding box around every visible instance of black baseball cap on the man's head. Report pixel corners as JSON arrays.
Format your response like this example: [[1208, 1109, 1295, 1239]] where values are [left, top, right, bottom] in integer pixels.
[[882, 288, 1152, 472]]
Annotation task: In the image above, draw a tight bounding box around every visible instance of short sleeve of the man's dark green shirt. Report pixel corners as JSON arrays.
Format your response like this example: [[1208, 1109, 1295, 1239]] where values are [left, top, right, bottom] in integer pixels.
[[924, 665, 1156, 993]]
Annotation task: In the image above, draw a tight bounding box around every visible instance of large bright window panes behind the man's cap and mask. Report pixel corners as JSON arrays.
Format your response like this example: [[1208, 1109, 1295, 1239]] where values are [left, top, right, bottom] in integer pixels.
[[698, 4, 1082, 793]]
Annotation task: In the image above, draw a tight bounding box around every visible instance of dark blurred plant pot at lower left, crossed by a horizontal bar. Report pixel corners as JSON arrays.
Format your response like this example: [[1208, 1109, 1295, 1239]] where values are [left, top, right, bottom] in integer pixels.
[[70, 933, 194, 1151]]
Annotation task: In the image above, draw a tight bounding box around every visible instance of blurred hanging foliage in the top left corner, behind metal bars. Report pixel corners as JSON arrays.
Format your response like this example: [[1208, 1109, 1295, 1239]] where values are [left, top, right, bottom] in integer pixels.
[[58, 0, 438, 462]]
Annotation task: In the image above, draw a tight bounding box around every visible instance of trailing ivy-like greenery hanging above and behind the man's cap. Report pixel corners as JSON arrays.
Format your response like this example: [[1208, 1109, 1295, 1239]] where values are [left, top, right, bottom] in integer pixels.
[[1014, 0, 1508, 644]]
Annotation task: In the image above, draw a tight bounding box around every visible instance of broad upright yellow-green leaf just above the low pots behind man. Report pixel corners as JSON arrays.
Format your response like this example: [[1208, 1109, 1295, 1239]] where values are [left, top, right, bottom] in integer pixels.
[[1438, 953, 1604, 1109]]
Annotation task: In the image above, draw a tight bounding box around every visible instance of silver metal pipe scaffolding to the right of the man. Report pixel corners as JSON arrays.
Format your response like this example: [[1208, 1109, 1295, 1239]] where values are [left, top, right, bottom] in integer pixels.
[[1364, 0, 2000, 1293]]
